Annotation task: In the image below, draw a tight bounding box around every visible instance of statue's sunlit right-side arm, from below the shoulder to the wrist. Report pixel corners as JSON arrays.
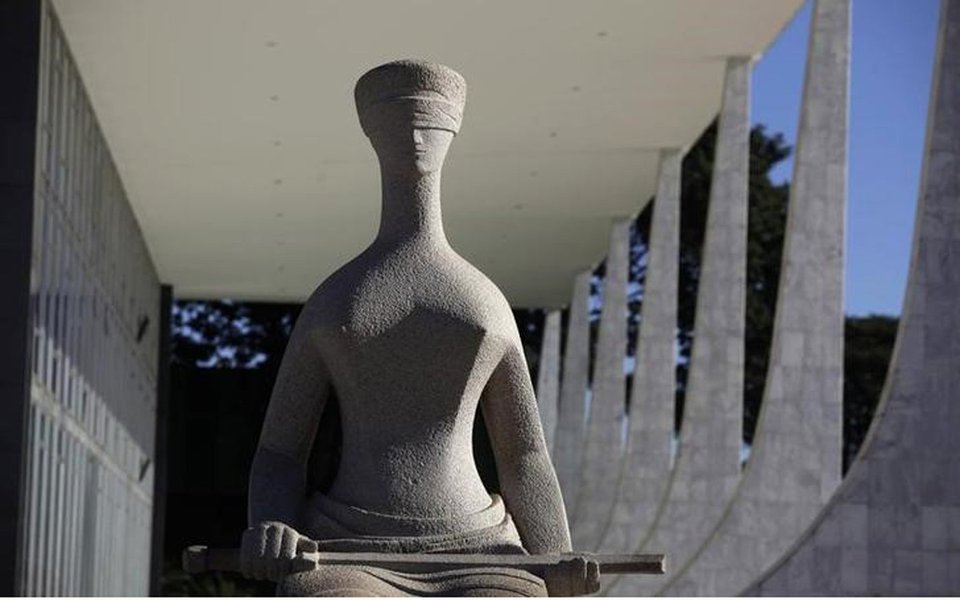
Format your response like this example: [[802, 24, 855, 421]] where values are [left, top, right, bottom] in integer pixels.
[[481, 336, 571, 554]]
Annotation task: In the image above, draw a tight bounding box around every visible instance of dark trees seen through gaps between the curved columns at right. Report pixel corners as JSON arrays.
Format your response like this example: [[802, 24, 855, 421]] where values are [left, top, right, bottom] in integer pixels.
[[591, 122, 897, 469]]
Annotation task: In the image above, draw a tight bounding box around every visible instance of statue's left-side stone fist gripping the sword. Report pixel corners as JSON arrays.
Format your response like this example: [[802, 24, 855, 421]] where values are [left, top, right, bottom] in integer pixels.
[[240, 521, 317, 582]]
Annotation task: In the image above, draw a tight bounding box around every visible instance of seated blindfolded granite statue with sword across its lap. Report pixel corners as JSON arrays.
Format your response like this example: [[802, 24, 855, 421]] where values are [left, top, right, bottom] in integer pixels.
[[241, 61, 570, 595]]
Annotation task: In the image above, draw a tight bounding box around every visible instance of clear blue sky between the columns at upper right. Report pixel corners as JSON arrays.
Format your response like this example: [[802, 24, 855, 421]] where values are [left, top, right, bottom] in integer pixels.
[[752, 0, 939, 315]]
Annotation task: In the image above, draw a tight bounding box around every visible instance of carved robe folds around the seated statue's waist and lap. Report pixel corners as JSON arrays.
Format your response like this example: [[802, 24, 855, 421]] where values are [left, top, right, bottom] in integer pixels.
[[278, 493, 546, 596]]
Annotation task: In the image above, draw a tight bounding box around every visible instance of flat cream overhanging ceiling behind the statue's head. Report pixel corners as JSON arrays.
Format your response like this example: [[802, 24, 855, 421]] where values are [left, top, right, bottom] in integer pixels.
[[54, 0, 802, 306]]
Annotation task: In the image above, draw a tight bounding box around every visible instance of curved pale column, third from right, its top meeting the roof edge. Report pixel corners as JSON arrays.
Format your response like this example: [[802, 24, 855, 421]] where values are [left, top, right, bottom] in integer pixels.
[[610, 58, 751, 596]]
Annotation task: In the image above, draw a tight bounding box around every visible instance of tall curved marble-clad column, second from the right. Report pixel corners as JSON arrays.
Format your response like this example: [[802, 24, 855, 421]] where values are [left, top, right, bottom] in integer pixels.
[[661, 0, 850, 596]]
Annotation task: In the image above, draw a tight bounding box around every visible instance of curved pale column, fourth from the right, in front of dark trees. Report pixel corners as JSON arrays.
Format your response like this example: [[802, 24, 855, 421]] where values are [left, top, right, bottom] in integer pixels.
[[595, 150, 683, 553]]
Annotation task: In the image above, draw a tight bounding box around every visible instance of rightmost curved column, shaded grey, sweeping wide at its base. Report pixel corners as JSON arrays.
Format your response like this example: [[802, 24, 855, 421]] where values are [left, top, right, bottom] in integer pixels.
[[750, 0, 960, 596]]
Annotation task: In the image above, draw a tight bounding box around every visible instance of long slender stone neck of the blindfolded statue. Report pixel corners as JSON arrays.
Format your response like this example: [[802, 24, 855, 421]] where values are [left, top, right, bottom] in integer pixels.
[[377, 168, 447, 244]]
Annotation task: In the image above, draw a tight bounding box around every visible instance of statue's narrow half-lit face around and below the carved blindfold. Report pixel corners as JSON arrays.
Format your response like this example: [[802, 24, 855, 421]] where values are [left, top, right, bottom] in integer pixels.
[[368, 106, 454, 175]]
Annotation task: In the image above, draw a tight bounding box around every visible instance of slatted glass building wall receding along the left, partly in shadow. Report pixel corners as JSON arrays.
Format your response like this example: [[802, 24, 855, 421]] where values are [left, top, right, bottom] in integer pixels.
[[17, 3, 160, 595]]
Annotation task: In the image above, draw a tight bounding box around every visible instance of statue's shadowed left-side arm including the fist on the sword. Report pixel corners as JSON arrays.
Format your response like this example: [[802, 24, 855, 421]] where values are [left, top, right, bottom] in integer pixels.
[[241, 323, 331, 581]]
